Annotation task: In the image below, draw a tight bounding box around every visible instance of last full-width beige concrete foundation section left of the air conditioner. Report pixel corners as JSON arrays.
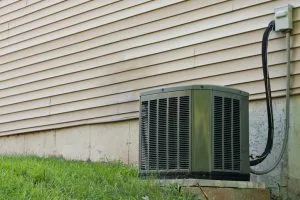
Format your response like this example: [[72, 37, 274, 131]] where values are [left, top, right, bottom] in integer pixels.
[[90, 121, 130, 163]]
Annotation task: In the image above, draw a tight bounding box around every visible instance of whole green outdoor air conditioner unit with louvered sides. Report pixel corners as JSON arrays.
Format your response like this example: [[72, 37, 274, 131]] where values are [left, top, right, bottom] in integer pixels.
[[139, 85, 250, 180]]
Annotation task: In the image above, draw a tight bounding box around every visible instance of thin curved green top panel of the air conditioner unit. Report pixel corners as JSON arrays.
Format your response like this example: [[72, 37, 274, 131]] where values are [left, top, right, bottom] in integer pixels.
[[141, 85, 249, 96]]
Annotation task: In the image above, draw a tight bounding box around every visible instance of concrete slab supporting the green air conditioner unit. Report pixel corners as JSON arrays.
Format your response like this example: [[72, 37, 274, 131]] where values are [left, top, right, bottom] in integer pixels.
[[158, 179, 271, 200]]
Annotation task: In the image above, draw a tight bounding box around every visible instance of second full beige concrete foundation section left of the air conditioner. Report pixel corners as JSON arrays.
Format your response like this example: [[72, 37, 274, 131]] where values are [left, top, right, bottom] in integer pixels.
[[55, 125, 90, 160]]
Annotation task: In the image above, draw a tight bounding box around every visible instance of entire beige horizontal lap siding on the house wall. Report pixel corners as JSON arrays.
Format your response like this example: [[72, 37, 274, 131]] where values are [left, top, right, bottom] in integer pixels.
[[0, 0, 300, 136]]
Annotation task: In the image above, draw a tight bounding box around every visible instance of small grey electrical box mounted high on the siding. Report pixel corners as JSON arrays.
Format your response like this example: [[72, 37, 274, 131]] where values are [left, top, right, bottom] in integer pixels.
[[275, 5, 293, 31]]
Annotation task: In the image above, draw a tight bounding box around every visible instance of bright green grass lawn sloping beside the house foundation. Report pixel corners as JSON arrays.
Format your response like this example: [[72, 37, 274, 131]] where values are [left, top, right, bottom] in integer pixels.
[[0, 156, 189, 200]]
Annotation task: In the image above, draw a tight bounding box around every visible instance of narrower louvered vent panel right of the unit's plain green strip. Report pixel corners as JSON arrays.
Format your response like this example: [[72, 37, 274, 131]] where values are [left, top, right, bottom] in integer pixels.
[[213, 96, 241, 171]]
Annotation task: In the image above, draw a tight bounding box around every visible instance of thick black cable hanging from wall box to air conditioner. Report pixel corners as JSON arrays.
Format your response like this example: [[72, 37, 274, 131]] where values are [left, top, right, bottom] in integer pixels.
[[250, 21, 275, 166]]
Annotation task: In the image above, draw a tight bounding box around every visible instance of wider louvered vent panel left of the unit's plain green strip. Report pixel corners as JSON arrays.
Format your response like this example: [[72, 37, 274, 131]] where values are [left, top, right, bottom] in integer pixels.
[[140, 96, 191, 172]]
